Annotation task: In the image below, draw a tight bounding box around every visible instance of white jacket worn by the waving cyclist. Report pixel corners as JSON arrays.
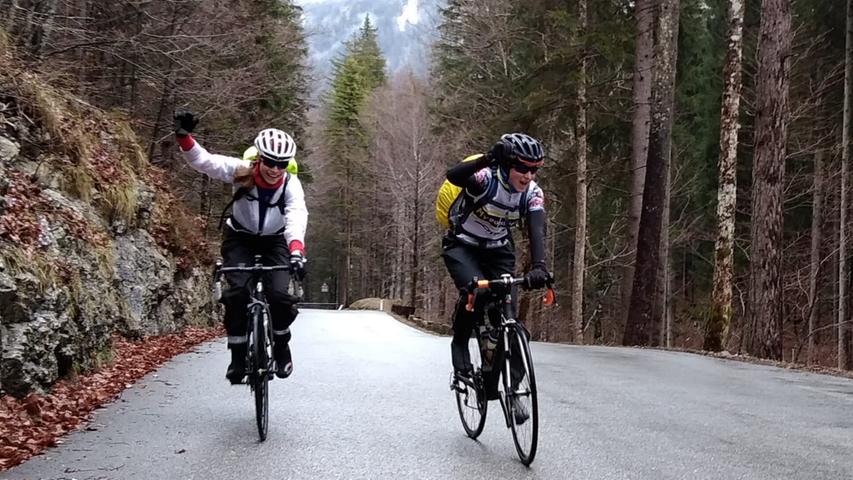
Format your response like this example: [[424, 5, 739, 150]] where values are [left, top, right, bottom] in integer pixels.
[[184, 142, 308, 245]]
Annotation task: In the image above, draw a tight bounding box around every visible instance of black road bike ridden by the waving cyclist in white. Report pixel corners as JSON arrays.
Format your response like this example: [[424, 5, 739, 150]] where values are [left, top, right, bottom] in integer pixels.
[[213, 255, 302, 442]]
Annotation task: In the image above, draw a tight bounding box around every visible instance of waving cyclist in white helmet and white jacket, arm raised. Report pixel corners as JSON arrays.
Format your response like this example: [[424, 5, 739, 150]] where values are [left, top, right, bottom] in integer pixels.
[[175, 112, 308, 384]]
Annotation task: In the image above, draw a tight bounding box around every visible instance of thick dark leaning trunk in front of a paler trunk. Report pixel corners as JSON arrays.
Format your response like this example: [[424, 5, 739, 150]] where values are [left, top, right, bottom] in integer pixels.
[[623, 0, 679, 345]]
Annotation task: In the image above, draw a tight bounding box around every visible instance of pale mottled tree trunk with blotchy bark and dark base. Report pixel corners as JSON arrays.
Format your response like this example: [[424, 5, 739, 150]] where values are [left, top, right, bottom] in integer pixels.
[[704, 0, 744, 352]]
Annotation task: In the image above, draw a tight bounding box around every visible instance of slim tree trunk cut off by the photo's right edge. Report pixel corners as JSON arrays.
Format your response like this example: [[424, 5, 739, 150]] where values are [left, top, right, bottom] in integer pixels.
[[838, 0, 853, 369]]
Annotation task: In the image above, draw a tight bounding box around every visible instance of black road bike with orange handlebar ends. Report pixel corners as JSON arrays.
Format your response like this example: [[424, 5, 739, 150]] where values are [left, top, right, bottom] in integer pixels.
[[450, 274, 555, 466]]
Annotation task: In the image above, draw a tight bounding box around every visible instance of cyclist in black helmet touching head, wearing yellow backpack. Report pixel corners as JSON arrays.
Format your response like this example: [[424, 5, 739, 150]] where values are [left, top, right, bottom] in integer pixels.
[[442, 133, 550, 423]]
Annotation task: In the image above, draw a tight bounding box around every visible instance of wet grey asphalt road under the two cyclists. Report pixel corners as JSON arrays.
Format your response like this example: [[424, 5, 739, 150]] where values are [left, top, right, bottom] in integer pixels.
[[5, 310, 853, 480]]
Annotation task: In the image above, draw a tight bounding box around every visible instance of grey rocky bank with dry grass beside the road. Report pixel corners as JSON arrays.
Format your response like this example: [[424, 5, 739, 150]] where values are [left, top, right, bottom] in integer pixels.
[[0, 129, 217, 397]]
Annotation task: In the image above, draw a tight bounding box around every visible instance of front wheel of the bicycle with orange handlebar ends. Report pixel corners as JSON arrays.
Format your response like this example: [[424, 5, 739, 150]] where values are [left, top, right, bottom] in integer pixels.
[[502, 327, 539, 465]]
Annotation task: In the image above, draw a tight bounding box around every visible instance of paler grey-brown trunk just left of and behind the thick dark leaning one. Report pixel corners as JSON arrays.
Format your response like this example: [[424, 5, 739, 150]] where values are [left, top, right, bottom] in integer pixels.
[[621, 0, 657, 334]]
